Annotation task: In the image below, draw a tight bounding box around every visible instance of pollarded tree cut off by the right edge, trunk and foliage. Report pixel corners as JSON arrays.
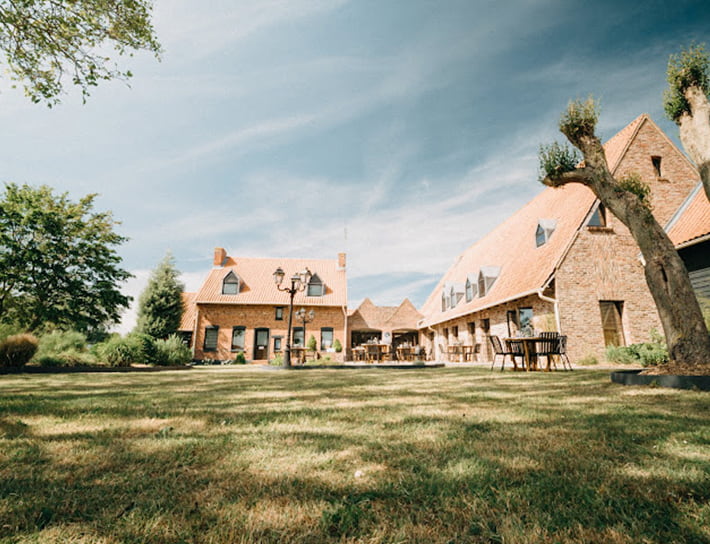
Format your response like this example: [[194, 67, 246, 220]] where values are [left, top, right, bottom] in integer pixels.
[[664, 45, 710, 199]]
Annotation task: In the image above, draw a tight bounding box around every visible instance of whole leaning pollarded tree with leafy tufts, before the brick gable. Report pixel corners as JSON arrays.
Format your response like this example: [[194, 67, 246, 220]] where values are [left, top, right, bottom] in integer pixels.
[[540, 98, 710, 373]]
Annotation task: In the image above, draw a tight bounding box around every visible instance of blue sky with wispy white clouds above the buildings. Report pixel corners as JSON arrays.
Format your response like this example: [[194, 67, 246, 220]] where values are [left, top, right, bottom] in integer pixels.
[[0, 0, 710, 332]]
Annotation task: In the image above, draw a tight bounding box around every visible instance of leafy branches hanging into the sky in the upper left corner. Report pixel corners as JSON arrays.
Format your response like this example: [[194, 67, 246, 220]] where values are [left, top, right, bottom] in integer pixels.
[[0, 0, 160, 107]]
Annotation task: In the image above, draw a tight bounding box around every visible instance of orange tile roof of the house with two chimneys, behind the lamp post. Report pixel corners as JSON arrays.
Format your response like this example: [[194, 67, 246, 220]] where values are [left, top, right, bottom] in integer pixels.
[[195, 257, 348, 306]]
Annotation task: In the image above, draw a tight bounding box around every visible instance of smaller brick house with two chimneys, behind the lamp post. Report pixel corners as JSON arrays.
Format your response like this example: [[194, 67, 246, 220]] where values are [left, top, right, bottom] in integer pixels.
[[180, 248, 347, 361]]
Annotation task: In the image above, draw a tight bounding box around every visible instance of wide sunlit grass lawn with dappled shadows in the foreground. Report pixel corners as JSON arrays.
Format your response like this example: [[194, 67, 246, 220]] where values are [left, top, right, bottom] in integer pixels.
[[0, 368, 710, 544]]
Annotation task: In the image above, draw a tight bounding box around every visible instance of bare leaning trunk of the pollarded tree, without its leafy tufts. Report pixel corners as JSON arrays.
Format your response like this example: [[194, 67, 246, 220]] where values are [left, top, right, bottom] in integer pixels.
[[544, 135, 710, 372]]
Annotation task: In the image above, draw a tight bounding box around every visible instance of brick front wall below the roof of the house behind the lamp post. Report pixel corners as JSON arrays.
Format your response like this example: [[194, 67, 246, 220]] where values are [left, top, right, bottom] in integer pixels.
[[194, 304, 346, 361]]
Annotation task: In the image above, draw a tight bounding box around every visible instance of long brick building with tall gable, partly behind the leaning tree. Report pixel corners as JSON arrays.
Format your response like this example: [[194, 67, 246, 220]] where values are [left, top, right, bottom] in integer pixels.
[[420, 114, 699, 359]]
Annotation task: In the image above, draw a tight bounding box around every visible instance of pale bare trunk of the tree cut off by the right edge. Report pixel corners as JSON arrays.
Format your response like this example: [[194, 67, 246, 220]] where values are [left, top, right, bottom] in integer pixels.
[[678, 86, 710, 200]]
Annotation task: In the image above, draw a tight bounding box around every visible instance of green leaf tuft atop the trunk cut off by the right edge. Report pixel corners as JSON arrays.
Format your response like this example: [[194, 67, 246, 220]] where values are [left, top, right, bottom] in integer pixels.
[[663, 45, 710, 123]]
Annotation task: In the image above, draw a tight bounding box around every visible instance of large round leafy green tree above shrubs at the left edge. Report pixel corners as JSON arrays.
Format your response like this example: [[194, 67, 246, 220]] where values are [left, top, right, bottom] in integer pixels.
[[0, 183, 130, 333]]
